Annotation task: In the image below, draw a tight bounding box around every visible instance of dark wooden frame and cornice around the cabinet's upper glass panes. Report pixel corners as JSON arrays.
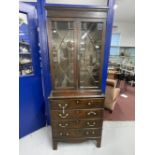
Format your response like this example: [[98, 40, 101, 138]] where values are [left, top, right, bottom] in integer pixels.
[[46, 7, 107, 91]]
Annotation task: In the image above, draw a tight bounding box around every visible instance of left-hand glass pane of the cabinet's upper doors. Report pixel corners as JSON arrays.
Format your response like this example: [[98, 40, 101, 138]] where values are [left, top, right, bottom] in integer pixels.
[[50, 21, 75, 88]]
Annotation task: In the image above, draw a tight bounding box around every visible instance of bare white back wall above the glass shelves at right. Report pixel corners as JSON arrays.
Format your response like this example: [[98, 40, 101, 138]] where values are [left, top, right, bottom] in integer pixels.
[[113, 22, 135, 47]]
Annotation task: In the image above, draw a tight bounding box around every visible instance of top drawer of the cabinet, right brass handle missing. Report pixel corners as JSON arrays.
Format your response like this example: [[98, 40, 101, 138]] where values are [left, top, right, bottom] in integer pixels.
[[50, 98, 104, 110]]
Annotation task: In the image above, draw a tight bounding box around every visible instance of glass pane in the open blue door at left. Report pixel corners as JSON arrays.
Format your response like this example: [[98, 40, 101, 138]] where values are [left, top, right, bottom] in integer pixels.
[[19, 13, 33, 75]]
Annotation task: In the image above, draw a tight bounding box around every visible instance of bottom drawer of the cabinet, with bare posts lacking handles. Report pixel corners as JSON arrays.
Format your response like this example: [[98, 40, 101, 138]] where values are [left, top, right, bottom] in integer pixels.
[[52, 129, 102, 138]]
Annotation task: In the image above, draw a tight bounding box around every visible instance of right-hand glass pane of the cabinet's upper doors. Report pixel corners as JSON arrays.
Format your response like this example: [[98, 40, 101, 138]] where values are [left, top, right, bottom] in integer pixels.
[[79, 22, 103, 88]]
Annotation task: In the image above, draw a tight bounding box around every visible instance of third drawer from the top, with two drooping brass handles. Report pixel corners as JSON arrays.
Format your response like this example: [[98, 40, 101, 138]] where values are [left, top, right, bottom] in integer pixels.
[[52, 119, 103, 129]]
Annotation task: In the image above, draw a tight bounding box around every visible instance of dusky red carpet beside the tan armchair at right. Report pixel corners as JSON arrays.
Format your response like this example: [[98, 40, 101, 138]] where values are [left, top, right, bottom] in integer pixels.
[[104, 86, 135, 121]]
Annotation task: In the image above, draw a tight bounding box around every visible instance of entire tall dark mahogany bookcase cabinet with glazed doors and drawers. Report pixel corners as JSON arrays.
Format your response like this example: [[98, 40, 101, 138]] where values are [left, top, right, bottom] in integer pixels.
[[47, 7, 107, 149]]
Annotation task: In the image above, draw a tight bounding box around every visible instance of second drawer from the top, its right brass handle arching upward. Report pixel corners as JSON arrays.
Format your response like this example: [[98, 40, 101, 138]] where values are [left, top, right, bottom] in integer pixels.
[[51, 109, 103, 120]]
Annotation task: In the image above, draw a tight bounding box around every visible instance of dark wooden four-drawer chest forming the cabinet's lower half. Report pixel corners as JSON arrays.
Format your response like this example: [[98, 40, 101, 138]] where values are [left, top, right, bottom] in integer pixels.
[[49, 96, 104, 149]]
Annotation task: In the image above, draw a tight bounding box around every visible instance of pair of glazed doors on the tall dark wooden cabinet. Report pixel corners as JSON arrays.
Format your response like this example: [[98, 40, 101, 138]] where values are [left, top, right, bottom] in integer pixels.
[[49, 19, 104, 89]]
